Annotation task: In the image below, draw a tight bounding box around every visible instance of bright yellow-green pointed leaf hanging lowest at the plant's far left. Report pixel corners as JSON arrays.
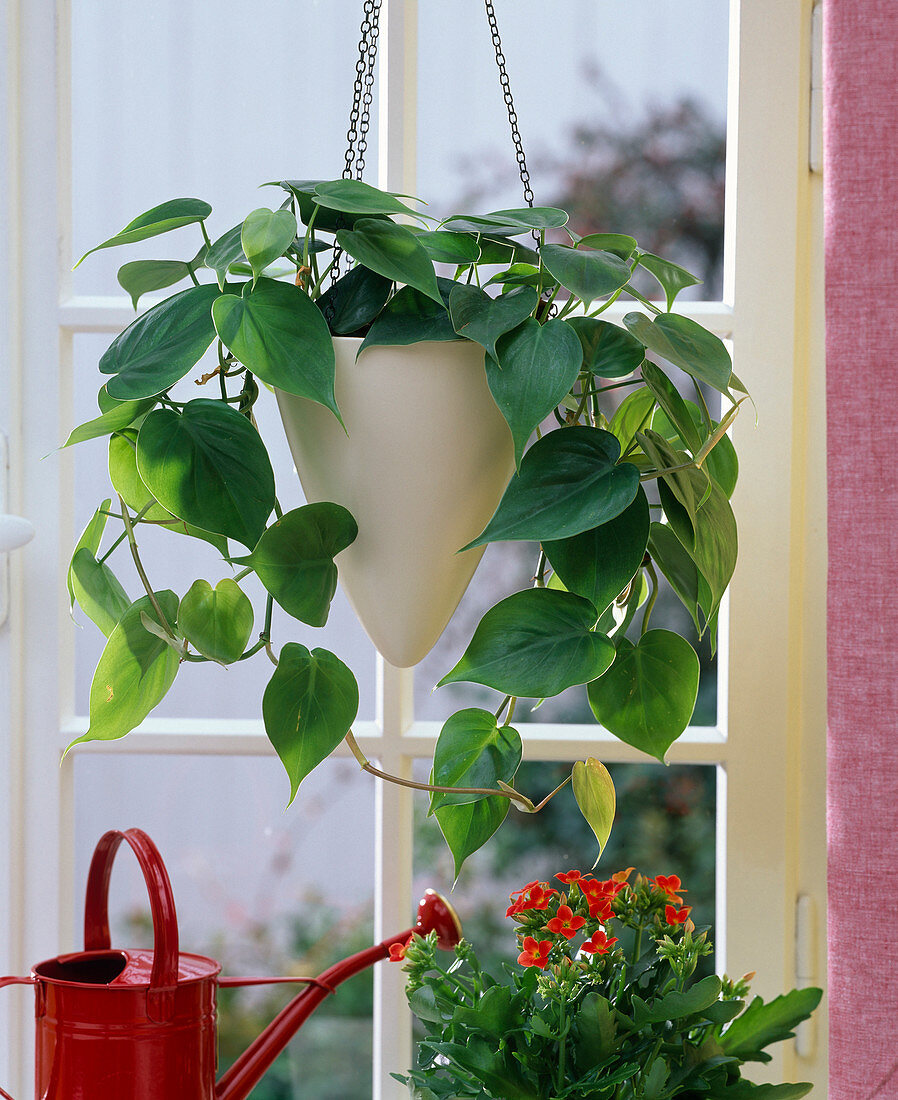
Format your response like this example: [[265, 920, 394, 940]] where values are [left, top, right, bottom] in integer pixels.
[[69, 591, 179, 748]]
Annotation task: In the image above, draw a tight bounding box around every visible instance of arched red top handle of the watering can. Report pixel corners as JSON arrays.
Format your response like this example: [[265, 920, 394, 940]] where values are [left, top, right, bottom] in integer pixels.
[[85, 828, 178, 1021]]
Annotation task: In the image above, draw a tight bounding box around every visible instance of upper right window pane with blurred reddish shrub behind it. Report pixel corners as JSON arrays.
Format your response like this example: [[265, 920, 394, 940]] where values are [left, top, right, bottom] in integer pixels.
[[417, 0, 730, 298]]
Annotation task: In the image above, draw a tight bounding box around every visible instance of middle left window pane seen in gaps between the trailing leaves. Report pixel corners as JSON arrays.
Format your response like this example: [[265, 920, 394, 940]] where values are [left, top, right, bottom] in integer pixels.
[[68, 327, 375, 721]]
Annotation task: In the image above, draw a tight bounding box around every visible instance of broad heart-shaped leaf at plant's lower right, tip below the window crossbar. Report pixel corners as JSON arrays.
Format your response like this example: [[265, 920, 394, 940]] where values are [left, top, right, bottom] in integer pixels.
[[587, 630, 699, 763]]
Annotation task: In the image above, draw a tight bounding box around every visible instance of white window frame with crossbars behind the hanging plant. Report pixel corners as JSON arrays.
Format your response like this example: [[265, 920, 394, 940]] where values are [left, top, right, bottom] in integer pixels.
[[0, 0, 825, 1098]]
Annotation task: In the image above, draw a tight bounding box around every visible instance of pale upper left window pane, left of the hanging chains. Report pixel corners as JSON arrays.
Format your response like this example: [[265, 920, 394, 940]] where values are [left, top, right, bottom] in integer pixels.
[[72, 0, 377, 294]]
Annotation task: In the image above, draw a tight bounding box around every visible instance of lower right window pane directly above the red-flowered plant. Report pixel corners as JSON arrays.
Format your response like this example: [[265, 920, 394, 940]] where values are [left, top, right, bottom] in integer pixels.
[[415, 761, 716, 972]]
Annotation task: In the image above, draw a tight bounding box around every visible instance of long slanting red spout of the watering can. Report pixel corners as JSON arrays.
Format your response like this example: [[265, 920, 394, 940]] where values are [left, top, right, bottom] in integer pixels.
[[216, 890, 461, 1100]]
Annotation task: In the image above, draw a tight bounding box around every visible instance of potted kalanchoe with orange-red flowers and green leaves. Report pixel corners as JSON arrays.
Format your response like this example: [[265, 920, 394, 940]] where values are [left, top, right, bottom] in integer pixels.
[[391, 867, 821, 1100]]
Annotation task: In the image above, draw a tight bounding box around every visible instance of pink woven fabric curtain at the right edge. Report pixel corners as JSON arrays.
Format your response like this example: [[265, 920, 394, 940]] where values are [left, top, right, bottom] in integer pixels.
[[823, 0, 898, 1100]]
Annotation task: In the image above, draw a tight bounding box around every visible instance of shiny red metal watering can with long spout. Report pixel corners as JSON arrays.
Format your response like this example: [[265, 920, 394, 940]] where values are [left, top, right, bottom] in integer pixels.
[[0, 828, 461, 1100]]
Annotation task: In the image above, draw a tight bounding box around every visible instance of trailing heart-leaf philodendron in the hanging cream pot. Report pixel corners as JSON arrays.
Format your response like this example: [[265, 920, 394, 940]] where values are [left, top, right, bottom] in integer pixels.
[[66, 179, 744, 867]]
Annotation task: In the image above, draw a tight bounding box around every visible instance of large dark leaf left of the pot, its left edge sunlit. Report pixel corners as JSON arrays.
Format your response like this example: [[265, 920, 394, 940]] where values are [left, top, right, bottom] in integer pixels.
[[138, 398, 274, 548]]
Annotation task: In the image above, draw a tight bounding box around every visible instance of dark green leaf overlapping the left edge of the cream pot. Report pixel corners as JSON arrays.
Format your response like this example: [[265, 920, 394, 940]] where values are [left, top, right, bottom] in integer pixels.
[[234, 502, 359, 626]]
